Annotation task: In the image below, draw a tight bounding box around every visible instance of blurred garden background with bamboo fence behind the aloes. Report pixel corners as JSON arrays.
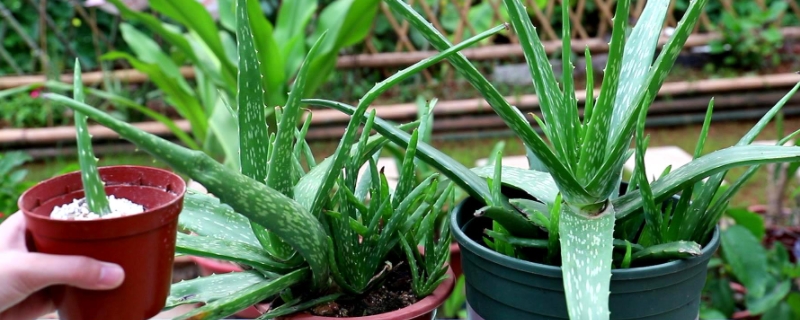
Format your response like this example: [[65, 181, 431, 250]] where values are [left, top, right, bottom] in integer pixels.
[[0, 0, 800, 319]]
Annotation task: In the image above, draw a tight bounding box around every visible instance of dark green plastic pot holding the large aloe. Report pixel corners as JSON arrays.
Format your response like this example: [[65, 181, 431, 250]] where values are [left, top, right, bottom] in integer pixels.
[[450, 191, 719, 320]]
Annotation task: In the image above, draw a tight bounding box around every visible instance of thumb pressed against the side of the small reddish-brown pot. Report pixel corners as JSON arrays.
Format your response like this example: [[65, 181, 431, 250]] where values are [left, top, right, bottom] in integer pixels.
[[11, 253, 125, 294]]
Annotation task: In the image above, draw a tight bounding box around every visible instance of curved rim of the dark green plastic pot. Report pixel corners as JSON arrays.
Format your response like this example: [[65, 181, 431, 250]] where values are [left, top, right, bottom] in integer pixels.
[[450, 197, 719, 280]]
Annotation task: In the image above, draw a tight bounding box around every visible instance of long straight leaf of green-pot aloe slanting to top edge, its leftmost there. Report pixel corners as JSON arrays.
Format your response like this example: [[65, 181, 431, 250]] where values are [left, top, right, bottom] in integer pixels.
[[384, 0, 594, 205]]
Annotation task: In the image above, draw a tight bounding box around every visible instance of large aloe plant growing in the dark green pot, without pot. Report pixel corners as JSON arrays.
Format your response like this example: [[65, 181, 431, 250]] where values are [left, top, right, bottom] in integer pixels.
[[306, 0, 800, 319]]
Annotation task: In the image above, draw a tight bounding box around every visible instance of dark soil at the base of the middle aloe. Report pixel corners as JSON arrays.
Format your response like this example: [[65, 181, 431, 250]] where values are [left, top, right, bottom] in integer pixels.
[[308, 263, 417, 318]]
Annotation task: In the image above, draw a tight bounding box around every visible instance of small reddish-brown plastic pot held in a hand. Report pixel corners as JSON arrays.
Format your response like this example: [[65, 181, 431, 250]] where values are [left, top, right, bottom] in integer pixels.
[[19, 166, 186, 320]]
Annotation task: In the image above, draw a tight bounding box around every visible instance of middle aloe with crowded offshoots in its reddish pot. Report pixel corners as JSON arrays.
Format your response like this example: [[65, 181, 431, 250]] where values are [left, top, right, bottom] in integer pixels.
[[34, 0, 506, 319]]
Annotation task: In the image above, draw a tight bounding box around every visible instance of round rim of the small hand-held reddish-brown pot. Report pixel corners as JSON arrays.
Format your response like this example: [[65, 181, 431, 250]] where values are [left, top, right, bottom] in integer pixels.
[[17, 165, 186, 224]]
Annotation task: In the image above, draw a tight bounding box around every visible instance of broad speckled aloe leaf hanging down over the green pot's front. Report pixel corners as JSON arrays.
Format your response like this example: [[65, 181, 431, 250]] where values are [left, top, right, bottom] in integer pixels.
[[558, 204, 614, 319]]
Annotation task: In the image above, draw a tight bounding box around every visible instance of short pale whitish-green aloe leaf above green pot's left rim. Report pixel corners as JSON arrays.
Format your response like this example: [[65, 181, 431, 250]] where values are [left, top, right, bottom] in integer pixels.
[[471, 166, 558, 205]]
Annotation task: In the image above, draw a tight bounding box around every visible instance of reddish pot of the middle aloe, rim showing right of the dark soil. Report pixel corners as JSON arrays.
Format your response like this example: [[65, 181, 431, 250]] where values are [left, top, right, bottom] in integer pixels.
[[279, 267, 455, 320]]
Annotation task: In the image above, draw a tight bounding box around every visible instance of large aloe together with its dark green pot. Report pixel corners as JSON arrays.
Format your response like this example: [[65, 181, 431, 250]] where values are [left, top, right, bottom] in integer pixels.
[[307, 0, 800, 319]]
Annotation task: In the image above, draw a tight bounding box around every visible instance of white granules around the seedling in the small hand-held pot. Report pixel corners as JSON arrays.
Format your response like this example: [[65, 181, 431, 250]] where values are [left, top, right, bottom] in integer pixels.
[[50, 195, 144, 220]]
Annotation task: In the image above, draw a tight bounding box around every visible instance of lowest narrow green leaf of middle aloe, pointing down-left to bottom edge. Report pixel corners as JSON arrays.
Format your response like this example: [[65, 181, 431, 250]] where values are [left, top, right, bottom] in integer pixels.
[[175, 268, 309, 320]]
